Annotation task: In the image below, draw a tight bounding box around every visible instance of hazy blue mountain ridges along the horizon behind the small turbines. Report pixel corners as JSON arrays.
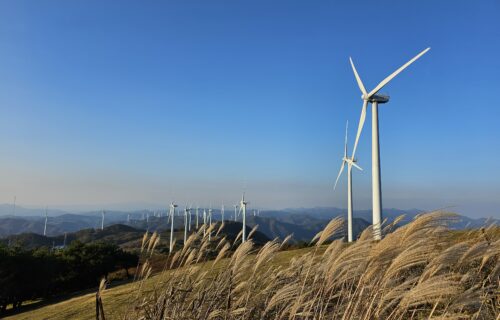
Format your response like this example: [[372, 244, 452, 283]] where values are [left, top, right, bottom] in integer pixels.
[[0, 204, 499, 241]]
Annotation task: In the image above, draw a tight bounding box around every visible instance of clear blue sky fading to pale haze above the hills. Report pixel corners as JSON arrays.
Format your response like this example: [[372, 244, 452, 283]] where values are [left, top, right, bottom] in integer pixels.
[[0, 0, 500, 217]]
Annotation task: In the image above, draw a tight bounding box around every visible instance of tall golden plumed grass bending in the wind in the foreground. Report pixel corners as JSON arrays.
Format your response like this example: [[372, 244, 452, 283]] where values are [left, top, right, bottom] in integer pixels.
[[119, 212, 500, 320]]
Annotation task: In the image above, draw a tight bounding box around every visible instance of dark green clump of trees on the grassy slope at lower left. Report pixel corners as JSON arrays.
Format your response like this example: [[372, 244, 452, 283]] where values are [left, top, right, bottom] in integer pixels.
[[0, 241, 138, 313]]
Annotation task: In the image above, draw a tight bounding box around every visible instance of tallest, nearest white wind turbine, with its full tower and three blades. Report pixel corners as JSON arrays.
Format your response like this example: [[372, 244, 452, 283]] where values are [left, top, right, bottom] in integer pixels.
[[349, 48, 430, 240]]
